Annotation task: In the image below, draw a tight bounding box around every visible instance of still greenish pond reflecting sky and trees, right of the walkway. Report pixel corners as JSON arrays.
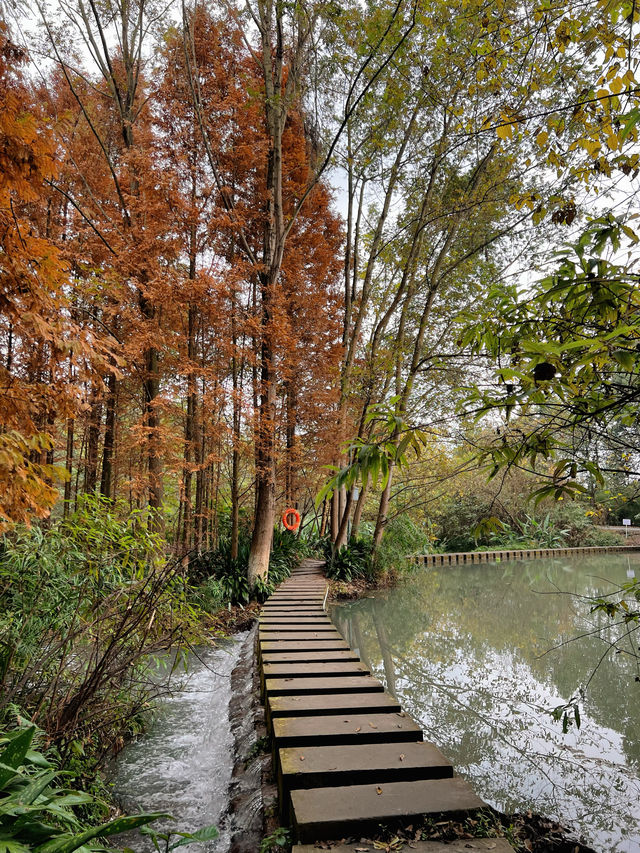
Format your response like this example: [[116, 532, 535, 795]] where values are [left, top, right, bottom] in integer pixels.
[[332, 554, 640, 853]]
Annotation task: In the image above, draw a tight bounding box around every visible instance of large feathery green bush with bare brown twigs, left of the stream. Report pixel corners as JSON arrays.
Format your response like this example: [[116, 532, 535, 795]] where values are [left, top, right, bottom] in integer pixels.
[[0, 499, 203, 755]]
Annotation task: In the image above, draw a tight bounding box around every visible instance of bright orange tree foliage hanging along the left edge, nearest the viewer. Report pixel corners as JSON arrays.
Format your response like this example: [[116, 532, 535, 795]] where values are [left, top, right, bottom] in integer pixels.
[[0, 22, 109, 530]]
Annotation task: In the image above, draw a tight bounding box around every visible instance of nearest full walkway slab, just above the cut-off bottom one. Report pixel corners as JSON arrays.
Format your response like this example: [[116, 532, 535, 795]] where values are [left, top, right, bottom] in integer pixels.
[[291, 777, 485, 844]]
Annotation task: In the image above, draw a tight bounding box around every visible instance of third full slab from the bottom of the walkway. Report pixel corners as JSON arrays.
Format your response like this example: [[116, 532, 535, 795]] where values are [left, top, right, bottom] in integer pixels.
[[271, 714, 422, 749]]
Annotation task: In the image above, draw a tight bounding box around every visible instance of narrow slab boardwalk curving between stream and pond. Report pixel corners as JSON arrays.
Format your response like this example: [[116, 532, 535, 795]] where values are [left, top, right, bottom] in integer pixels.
[[258, 560, 512, 853]]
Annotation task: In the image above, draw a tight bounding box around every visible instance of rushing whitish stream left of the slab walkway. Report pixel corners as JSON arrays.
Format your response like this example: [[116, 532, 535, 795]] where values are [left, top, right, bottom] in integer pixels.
[[113, 634, 245, 853]]
